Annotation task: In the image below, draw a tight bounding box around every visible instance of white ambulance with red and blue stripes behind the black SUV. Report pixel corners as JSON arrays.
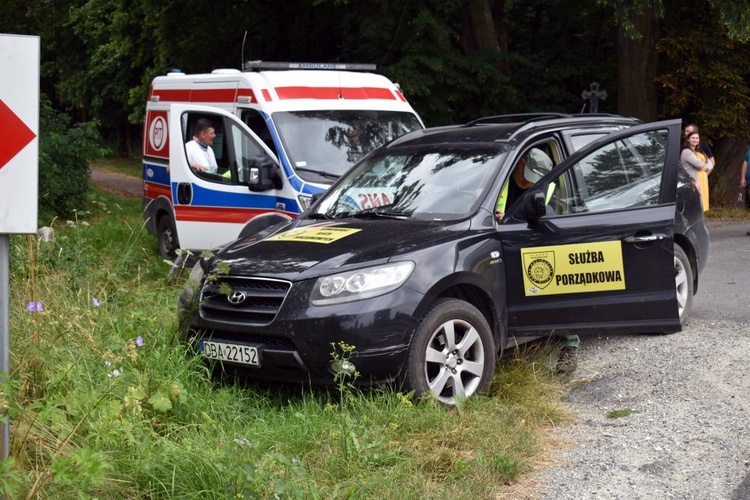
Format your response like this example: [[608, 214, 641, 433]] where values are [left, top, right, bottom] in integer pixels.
[[143, 61, 424, 259]]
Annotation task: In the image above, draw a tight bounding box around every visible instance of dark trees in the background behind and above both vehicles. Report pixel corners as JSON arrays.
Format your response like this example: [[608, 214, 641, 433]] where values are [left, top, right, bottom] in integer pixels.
[[0, 0, 750, 163]]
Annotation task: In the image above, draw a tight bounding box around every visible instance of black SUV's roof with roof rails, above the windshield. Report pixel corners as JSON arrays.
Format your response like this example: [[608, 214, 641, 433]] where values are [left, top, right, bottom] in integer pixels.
[[386, 113, 642, 148]]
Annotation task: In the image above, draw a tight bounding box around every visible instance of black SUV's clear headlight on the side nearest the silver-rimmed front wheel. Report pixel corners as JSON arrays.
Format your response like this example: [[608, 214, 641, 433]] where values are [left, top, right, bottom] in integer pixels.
[[310, 262, 414, 306]]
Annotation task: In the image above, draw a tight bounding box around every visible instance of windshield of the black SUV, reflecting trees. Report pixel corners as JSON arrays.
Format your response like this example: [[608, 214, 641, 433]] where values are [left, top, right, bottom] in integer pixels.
[[309, 145, 505, 220]]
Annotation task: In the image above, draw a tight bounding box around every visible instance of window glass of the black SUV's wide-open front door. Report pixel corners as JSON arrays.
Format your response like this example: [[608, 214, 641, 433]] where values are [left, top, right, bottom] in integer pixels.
[[547, 130, 667, 215]]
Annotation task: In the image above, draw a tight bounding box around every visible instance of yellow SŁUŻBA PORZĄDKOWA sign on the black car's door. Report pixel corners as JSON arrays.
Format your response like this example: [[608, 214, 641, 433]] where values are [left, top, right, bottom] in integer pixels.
[[521, 241, 625, 297]]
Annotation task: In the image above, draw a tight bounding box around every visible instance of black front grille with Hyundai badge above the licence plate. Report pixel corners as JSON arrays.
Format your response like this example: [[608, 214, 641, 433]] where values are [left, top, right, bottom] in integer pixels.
[[200, 276, 292, 325]]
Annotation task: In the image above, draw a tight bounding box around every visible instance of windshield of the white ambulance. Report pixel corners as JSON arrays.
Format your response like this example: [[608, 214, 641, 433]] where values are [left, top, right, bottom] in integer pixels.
[[273, 110, 422, 182]]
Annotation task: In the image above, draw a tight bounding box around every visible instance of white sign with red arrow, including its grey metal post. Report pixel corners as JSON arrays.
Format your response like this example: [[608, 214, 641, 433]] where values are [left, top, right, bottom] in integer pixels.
[[0, 34, 39, 459]]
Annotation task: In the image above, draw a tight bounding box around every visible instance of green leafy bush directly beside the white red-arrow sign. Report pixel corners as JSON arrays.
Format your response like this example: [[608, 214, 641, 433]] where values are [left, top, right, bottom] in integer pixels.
[[39, 96, 104, 223]]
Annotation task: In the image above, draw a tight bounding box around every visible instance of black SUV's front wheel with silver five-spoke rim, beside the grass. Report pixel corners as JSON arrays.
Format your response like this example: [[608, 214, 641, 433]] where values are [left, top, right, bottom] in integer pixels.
[[405, 298, 497, 406]]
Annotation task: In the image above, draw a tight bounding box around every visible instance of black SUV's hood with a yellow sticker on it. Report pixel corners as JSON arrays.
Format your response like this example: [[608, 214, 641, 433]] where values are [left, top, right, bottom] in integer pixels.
[[214, 219, 470, 281]]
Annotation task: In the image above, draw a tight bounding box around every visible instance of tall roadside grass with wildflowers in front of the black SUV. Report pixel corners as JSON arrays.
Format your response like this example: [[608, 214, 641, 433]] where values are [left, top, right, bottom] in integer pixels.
[[0, 187, 566, 499]]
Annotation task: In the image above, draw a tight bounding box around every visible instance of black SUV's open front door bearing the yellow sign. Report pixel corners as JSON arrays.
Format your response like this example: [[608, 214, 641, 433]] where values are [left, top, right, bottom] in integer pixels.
[[498, 120, 681, 337]]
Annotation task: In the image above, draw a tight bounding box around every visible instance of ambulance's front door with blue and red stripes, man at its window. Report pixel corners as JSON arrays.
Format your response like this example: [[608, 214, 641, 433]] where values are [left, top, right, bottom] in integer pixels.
[[169, 104, 282, 250]]
